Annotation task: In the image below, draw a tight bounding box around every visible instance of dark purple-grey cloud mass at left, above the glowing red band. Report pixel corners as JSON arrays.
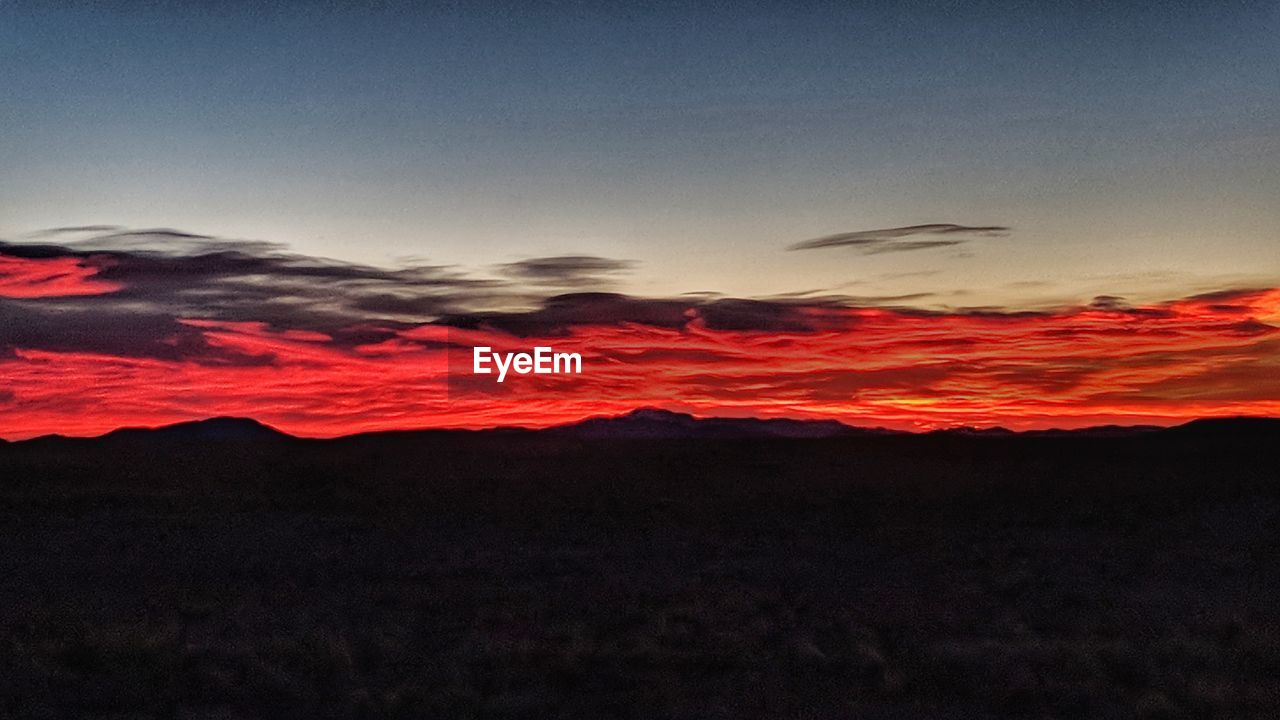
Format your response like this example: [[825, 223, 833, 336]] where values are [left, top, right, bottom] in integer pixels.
[[0, 225, 660, 363]]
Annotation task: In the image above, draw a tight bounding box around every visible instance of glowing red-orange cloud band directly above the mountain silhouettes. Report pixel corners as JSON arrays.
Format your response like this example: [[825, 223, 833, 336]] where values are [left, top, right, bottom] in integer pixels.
[[0, 285, 1280, 438]]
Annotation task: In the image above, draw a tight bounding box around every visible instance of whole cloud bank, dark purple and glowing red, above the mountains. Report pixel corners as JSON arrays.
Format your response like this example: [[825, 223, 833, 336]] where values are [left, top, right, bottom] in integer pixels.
[[0, 228, 1280, 438]]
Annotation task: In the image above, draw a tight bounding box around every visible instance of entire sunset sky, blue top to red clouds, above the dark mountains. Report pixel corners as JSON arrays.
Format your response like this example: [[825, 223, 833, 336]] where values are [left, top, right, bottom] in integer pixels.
[[0, 0, 1280, 438]]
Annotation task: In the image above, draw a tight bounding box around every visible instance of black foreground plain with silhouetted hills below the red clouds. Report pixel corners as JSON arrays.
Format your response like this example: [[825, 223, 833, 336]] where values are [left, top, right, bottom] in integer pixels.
[[0, 421, 1280, 719]]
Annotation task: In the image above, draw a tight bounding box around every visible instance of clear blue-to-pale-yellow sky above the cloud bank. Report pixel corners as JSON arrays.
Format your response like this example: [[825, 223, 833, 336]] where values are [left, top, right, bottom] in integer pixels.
[[0, 1, 1280, 306]]
